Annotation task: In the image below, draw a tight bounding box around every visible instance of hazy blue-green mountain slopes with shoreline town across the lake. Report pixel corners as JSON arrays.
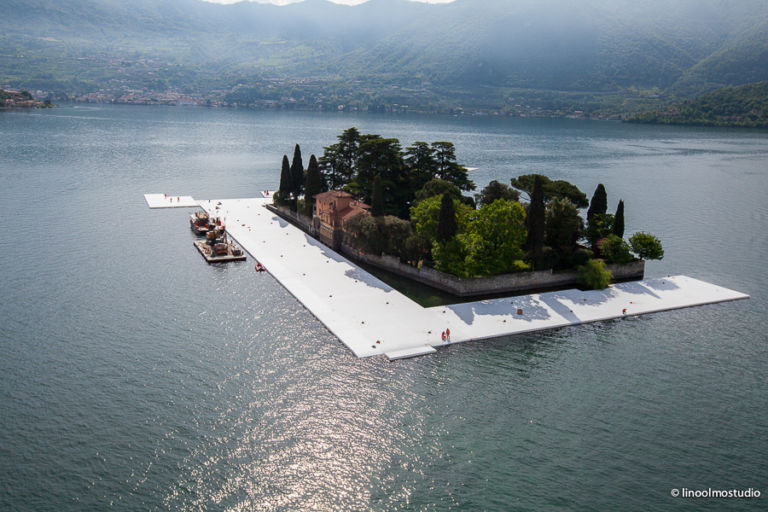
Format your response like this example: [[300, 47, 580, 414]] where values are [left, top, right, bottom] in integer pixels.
[[0, 0, 768, 111]]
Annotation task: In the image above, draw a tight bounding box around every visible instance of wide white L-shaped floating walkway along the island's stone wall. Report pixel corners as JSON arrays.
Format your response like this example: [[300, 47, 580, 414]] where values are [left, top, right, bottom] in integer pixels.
[[147, 195, 748, 359]]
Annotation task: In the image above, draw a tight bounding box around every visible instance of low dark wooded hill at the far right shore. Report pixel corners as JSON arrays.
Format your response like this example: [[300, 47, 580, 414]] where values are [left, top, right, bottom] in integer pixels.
[[626, 82, 768, 128]]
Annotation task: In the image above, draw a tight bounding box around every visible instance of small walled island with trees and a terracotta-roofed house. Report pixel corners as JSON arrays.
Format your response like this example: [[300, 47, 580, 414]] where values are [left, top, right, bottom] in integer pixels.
[[273, 128, 664, 296]]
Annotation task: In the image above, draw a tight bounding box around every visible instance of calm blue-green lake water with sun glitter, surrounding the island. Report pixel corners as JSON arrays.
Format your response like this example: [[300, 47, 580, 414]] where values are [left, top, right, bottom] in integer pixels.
[[0, 106, 768, 511]]
